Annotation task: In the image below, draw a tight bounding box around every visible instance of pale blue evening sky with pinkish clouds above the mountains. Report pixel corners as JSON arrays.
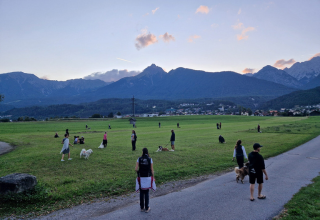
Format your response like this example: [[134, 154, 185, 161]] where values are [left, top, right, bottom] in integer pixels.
[[0, 0, 320, 81]]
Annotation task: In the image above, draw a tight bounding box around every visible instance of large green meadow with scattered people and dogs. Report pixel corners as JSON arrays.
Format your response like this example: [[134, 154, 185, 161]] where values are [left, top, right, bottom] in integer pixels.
[[0, 116, 320, 216]]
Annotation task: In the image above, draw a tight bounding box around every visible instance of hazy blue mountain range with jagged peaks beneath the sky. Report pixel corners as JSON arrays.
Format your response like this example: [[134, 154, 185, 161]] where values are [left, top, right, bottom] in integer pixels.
[[0, 57, 320, 111]]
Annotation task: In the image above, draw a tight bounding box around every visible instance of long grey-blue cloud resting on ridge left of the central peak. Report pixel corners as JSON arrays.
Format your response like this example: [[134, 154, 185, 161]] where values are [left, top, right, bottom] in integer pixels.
[[83, 69, 140, 82]]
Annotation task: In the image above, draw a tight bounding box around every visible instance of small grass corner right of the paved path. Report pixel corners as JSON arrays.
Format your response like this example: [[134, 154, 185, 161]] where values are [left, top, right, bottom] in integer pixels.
[[280, 176, 320, 220]]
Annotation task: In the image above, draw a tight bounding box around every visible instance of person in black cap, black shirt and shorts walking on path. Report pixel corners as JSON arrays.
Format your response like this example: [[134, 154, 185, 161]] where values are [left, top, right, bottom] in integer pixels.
[[249, 143, 268, 201]]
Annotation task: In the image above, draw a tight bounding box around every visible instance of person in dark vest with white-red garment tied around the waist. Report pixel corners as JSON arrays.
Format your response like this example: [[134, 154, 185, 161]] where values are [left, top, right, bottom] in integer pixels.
[[135, 148, 155, 212]]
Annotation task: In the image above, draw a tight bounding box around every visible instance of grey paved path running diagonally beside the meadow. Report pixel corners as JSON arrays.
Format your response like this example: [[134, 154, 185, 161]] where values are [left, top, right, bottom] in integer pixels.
[[93, 136, 320, 220]]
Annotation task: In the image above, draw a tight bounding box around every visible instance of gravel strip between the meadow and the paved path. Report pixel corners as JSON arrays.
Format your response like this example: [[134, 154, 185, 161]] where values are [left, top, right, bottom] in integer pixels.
[[36, 169, 233, 219]]
